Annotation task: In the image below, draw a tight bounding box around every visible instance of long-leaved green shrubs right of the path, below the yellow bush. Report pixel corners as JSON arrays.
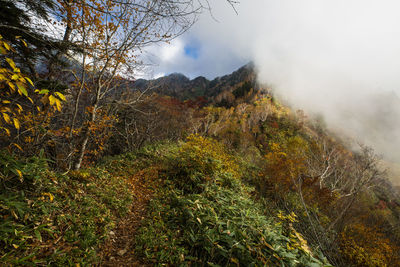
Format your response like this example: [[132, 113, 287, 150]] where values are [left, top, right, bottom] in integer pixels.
[[137, 177, 327, 266]]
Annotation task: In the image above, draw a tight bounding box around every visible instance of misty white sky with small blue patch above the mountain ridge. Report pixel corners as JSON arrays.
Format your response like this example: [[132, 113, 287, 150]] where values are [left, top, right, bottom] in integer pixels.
[[147, 0, 400, 172]]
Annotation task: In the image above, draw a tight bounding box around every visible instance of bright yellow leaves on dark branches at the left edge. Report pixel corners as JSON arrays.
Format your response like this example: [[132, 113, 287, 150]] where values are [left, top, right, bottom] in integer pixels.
[[0, 35, 66, 153]]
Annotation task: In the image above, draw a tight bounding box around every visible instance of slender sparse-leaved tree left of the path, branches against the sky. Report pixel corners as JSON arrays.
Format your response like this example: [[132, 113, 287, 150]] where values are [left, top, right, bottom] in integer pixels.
[[46, 0, 237, 169]]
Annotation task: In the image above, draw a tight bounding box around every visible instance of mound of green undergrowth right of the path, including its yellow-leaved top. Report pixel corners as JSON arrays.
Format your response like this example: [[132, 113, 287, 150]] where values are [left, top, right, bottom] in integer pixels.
[[137, 137, 330, 266]]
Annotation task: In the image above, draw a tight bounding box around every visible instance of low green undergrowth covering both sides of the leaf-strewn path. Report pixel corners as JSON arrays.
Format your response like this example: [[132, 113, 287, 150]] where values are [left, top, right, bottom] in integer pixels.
[[0, 136, 329, 266]]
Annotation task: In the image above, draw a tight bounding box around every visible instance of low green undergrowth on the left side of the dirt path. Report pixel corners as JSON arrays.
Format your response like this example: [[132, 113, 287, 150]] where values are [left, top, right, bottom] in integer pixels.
[[0, 153, 132, 266]]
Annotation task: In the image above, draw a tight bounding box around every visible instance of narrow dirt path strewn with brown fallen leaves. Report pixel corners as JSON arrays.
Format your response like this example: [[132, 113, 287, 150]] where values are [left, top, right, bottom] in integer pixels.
[[98, 167, 158, 266]]
